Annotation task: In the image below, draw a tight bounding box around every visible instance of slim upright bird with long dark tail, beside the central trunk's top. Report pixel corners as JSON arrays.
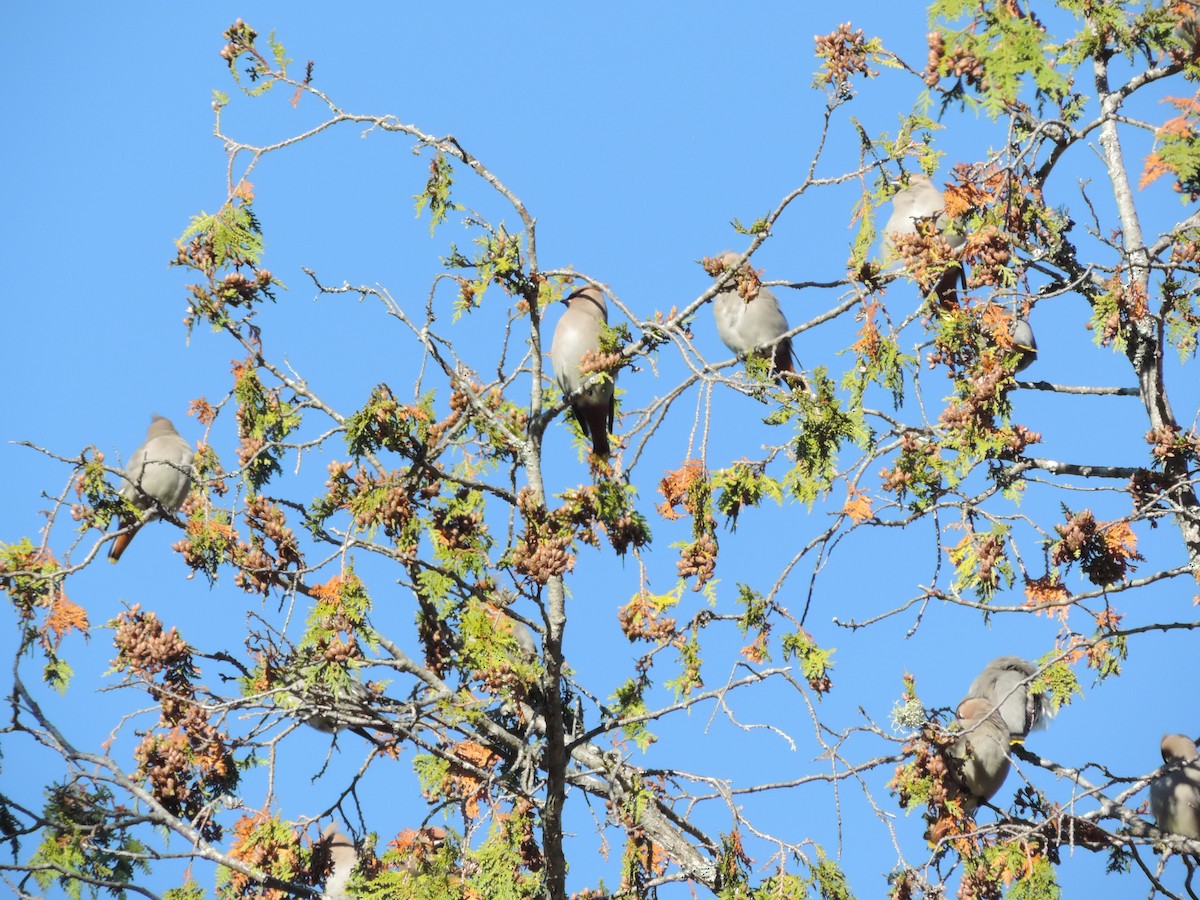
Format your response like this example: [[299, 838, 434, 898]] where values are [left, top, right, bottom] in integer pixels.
[[550, 284, 617, 460]]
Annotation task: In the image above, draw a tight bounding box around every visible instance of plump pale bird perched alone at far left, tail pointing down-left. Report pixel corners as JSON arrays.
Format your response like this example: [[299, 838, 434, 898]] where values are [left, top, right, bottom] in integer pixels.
[[108, 415, 194, 563]]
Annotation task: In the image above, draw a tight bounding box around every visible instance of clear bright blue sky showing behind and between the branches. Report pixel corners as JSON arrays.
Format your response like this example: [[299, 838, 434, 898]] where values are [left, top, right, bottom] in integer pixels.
[[0, 2, 1196, 896]]
